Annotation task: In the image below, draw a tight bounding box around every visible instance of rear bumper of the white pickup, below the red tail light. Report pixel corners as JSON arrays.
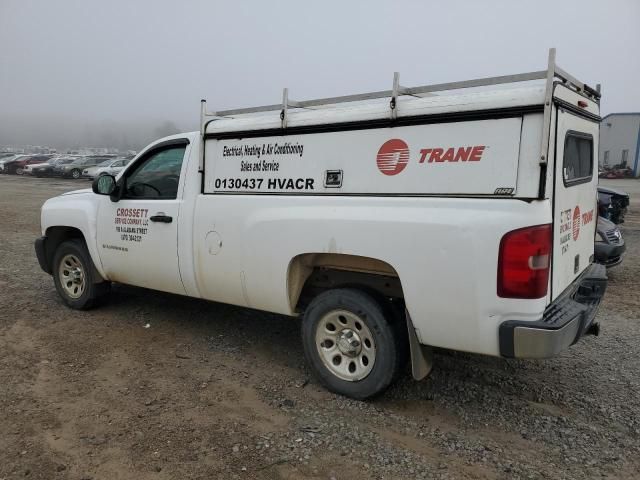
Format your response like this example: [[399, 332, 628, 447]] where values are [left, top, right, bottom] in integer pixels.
[[499, 263, 607, 358]]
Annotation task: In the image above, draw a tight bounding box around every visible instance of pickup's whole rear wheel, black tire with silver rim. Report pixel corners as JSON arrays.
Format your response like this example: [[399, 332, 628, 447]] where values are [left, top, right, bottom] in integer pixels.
[[302, 288, 408, 400]]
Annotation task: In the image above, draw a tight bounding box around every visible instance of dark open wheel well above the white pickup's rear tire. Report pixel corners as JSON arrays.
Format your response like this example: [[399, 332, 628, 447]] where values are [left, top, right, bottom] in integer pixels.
[[287, 253, 404, 312]]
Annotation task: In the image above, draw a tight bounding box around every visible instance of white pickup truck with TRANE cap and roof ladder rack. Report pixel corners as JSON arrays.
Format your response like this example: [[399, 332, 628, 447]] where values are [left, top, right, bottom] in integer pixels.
[[36, 50, 607, 398]]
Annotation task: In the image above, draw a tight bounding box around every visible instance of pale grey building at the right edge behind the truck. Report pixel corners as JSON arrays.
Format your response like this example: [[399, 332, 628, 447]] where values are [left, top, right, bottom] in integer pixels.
[[599, 112, 640, 177]]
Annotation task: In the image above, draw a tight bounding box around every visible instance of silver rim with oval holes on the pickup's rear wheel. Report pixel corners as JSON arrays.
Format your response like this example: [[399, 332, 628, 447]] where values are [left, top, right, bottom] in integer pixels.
[[316, 310, 376, 382]]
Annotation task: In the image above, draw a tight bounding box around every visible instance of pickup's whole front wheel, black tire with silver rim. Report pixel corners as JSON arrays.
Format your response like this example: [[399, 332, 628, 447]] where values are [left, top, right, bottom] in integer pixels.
[[52, 239, 111, 310]]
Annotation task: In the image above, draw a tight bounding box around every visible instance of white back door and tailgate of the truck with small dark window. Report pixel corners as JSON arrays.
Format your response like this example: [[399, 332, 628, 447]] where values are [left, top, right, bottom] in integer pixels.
[[551, 107, 598, 299]]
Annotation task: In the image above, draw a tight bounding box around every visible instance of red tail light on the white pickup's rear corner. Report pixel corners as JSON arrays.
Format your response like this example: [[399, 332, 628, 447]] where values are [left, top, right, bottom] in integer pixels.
[[498, 224, 553, 298]]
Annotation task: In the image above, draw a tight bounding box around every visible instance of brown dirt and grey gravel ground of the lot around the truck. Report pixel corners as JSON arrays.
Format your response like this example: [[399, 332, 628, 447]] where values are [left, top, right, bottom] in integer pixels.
[[0, 175, 640, 480]]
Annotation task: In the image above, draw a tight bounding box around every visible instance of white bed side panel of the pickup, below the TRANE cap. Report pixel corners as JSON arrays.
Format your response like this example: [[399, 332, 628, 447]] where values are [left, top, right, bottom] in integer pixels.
[[193, 195, 551, 355]]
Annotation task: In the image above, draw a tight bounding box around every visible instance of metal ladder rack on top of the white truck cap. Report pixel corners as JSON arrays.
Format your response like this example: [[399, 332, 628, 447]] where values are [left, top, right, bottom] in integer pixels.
[[200, 48, 600, 164]]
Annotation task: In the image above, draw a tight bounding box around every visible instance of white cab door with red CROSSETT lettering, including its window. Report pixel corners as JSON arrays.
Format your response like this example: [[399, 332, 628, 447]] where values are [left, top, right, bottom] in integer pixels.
[[97, 139, 189, 295]]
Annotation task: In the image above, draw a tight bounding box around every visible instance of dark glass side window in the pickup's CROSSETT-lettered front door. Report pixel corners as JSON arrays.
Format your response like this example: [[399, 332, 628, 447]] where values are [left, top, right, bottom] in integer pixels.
[[124, 146, 186, 199]]
